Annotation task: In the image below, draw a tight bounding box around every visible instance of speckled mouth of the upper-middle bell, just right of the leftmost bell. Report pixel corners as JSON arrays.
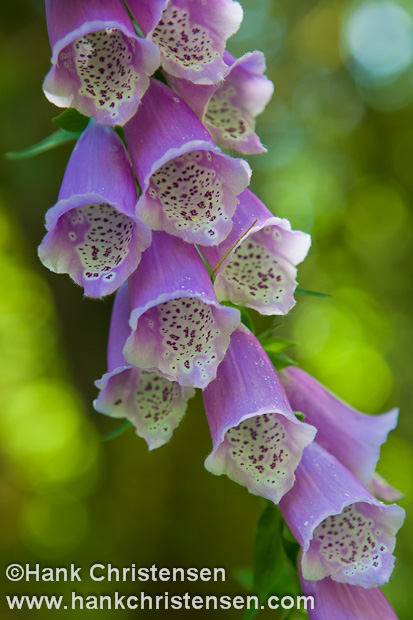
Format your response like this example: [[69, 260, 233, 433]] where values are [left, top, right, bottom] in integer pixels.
[[148, 151, 237, 245]]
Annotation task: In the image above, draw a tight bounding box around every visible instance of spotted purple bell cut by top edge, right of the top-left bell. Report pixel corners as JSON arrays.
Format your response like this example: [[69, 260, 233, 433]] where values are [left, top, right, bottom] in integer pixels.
[[127, 0, 243, 84]]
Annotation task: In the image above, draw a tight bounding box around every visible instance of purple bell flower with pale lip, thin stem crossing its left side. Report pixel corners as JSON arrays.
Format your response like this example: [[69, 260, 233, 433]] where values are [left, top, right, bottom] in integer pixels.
[[201, 189, 312, 314]]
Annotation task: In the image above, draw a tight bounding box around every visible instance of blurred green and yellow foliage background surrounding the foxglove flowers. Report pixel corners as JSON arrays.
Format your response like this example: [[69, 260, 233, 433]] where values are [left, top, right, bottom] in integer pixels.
[[0, 0, 413, 620]]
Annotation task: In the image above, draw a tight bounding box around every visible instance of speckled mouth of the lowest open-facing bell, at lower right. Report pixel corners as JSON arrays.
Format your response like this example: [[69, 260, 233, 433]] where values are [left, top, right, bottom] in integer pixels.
[[308, 502, 395, 587]]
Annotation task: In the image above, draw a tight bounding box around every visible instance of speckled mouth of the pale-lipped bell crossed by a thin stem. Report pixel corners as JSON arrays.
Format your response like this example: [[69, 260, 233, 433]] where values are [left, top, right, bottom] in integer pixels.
[[215, 226, 297, 314]]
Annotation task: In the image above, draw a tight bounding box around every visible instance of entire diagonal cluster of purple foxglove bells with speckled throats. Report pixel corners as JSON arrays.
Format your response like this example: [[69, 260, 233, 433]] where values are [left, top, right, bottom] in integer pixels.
[[39, 0, 404, 620]]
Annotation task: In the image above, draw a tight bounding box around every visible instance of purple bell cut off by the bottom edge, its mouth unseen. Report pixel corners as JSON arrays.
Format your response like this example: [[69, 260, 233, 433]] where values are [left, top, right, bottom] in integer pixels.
[[300, 574, 397, 620]]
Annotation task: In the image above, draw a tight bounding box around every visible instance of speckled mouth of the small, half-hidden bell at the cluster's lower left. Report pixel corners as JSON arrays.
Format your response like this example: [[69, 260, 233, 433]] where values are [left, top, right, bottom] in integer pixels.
[[95, 368, 194, 450]]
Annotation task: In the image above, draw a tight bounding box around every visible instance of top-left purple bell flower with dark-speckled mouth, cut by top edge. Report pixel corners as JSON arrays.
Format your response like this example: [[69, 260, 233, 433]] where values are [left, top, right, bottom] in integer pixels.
[[43, 0, 160, 125]]
